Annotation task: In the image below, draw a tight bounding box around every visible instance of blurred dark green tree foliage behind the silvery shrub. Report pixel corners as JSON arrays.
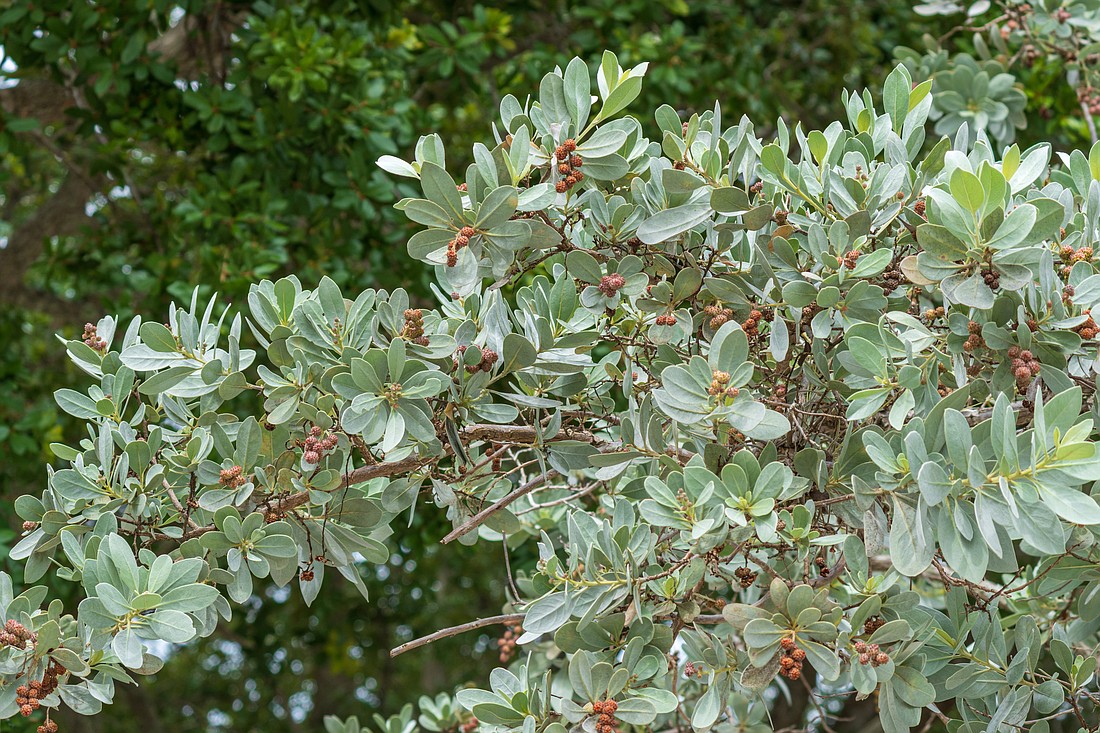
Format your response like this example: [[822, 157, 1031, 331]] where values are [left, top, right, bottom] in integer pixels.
[[0, 0, 1089, 732]]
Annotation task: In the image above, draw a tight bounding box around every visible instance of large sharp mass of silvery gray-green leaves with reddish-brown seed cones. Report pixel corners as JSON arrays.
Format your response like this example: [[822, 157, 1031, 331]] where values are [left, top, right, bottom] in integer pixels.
[[10, 54, 1100, 733]]
